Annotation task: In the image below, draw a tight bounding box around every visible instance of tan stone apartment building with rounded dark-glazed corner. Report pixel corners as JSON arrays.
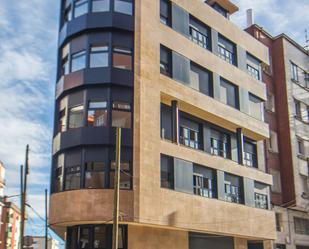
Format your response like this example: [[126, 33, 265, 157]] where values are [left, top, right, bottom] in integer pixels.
[[50, 0, 276, 249]]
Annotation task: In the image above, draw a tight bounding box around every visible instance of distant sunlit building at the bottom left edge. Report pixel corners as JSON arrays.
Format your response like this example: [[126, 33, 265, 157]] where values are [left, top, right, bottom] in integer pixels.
[[0, 201, 21, 249]]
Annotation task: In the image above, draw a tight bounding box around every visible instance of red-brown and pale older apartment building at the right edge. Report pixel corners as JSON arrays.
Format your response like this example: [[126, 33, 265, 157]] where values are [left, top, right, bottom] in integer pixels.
[[247, 25, 309, 249]]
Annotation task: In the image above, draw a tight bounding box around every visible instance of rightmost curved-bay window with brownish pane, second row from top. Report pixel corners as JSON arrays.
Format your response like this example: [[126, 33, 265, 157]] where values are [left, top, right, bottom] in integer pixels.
[[113, 47, 132, 70]]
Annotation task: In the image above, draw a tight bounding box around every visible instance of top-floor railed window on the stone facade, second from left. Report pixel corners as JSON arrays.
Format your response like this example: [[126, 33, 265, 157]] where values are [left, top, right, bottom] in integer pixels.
[[189, 16, 210, 49]]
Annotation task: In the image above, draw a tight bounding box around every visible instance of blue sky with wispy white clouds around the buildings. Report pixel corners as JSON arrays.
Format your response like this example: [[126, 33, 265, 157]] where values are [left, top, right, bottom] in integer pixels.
[[0, 0, 309, 245]]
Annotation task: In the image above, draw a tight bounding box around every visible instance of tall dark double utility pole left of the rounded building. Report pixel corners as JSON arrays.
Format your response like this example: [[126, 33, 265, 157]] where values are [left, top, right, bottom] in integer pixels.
[[20, 144, 29, 249]]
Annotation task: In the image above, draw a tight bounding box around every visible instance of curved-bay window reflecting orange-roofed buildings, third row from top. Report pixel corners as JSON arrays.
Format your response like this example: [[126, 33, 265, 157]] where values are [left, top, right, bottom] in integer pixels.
[[87, 101, 107, 126]]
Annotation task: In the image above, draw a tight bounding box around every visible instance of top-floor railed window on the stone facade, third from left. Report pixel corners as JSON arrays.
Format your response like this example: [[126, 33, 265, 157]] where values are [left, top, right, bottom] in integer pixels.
[[218, 35, 237, 66]]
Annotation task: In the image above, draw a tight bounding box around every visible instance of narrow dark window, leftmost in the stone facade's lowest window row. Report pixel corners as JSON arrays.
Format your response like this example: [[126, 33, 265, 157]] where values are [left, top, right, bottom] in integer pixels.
[[161, 154, 174, 189]]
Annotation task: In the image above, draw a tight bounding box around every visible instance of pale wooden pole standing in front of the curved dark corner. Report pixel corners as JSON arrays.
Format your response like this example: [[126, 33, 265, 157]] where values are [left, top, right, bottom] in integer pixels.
[[112, 127, 121, 249]]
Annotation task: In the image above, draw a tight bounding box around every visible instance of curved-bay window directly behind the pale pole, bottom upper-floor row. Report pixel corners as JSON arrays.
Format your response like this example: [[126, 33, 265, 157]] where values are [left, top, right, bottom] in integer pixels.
[[109, 162, 132, 189]]
